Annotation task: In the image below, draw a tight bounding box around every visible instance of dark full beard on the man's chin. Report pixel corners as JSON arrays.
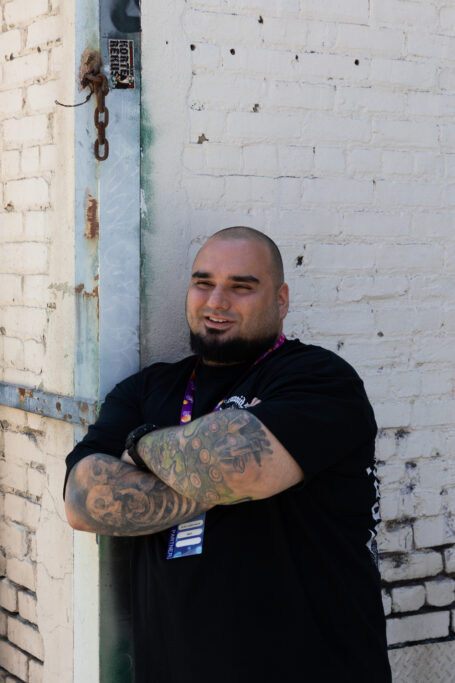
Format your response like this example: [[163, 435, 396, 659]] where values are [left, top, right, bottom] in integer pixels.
[[190, 330, 279, 365]]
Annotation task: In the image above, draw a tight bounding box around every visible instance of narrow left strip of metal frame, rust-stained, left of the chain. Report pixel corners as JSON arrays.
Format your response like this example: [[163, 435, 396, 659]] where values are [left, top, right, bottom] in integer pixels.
[[73, 0, 101, 683]]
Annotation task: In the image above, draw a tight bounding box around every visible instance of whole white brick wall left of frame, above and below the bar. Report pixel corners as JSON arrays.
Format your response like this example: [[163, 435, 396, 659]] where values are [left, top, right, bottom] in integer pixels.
[[0, 0, 74, 683]]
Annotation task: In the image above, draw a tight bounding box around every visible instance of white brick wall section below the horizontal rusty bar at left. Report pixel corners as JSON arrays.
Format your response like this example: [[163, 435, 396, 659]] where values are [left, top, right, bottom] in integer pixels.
[[0, 408, 73, 683]]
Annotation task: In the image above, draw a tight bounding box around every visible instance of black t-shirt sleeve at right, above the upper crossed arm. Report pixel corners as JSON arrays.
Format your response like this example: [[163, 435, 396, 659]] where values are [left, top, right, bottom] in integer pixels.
[[248, 347, 377, 481]]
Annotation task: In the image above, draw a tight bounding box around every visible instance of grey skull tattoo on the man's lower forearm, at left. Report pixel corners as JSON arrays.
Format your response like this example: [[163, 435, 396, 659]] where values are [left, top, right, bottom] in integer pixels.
[[66, 453, 211, 536]]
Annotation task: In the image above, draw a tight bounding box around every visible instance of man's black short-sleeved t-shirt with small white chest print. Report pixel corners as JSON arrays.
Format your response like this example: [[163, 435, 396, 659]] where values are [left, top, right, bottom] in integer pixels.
[[67, 341, 391, 683]]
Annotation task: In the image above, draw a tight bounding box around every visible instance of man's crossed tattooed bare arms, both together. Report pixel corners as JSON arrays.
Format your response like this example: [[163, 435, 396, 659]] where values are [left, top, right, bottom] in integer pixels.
[[65, 410, 303, 536]]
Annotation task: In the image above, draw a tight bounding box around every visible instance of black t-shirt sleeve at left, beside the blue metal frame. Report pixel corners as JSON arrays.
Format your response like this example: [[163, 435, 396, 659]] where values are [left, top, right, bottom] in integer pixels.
[[64, 373, 144, 490]]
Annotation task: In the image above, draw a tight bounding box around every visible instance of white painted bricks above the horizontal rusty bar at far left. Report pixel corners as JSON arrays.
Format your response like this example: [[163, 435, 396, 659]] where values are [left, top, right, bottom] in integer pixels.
[[0, 0, 63, 396]]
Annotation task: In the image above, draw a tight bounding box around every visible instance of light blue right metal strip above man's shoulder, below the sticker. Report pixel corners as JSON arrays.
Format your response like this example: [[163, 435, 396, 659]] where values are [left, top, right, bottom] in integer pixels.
[[99, 0, 141, 398]]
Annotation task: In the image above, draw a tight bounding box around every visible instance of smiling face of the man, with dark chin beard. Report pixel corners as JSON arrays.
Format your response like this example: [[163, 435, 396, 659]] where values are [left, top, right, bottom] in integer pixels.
[[186, 239, 289, 364]]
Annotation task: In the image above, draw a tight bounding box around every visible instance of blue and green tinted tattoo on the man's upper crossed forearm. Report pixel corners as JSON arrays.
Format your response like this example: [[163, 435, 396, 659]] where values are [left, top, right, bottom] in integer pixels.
[[137, 410, 272, 505]]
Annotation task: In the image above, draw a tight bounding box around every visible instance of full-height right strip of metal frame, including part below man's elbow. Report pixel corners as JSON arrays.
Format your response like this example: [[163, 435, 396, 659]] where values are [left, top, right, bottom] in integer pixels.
[[99, 0, 141, 683]]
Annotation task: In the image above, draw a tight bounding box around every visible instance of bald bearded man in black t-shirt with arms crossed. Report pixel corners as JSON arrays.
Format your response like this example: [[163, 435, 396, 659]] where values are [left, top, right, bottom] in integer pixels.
[[66, 227, 391, 683]]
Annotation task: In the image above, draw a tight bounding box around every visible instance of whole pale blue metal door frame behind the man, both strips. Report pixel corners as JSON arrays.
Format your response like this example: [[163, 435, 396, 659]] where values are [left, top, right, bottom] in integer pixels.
[[69, 5, 140, 683]]
